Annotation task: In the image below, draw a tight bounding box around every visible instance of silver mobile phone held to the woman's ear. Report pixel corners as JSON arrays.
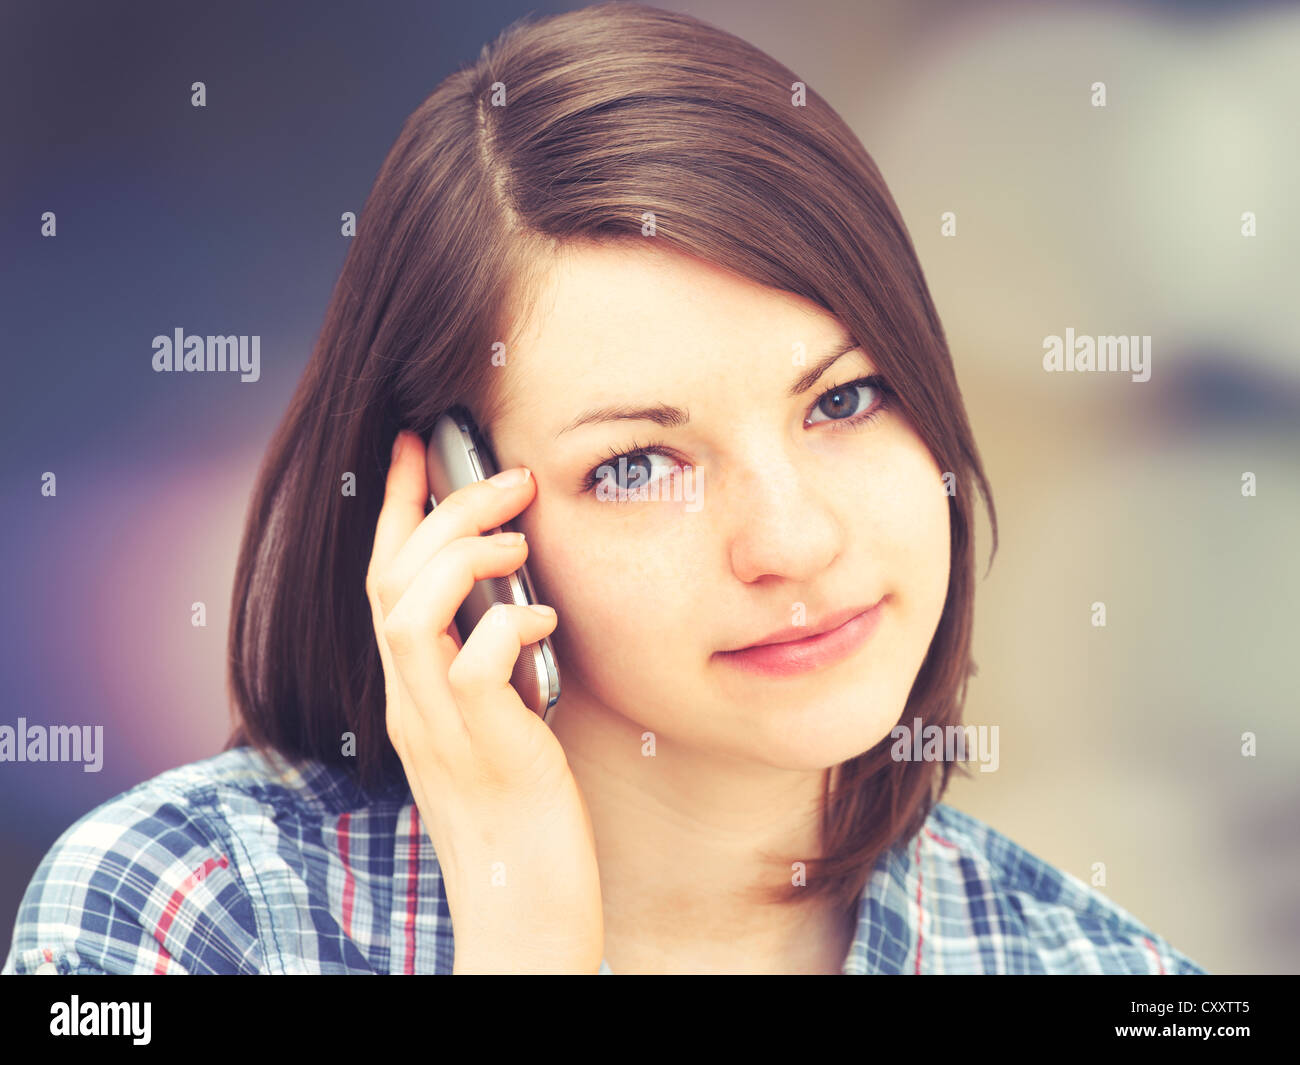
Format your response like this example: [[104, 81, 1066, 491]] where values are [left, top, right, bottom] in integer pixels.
[[425, 404, 560, 724]]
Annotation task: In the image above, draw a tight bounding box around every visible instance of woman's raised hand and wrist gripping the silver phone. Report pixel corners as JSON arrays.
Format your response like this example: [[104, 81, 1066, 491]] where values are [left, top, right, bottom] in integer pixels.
[[365, 432, 605, 973]]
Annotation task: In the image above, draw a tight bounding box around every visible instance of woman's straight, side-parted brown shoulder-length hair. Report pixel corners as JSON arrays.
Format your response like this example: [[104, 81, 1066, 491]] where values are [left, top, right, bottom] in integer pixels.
[[228, 3, 997, 909]]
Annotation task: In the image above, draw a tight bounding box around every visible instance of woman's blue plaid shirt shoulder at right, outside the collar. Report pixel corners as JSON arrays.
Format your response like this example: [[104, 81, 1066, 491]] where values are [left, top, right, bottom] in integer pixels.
[[922, 802, 1206, 975]]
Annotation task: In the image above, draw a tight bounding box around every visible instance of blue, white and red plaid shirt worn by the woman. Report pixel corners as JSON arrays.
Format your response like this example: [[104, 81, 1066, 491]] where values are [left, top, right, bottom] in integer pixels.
[[0, 748, 1205, 975]]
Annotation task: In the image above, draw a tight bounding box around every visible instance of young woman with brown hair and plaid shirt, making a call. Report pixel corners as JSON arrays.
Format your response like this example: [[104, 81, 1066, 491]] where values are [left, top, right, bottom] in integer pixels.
[[4, 4, 1203, 974]]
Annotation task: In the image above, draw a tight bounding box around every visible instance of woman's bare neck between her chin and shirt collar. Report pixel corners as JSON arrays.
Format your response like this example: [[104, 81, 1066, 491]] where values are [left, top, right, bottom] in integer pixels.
[[553, 693, 855, 973]]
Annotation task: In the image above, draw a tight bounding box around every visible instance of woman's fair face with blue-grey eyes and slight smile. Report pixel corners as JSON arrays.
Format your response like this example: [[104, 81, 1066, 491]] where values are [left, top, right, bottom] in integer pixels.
[[490, 239, 949, 770]]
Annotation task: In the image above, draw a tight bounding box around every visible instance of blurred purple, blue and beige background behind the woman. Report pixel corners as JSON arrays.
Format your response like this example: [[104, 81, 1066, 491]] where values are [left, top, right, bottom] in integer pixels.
[[0, 0, 1300, 973]]
